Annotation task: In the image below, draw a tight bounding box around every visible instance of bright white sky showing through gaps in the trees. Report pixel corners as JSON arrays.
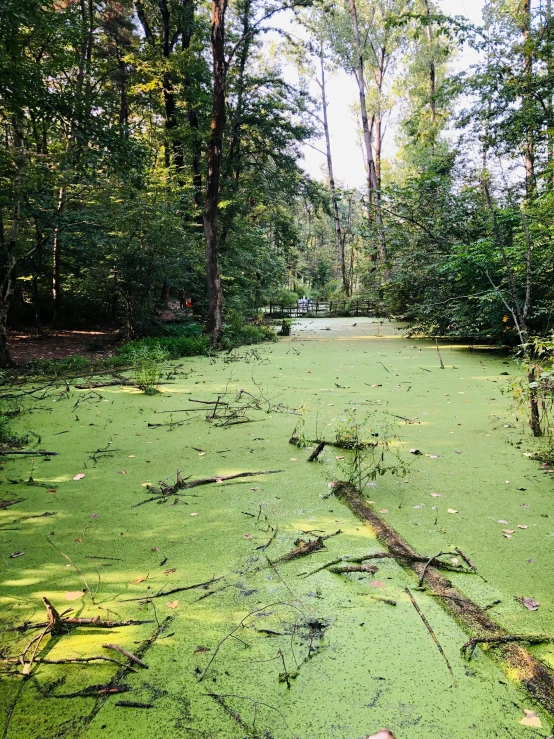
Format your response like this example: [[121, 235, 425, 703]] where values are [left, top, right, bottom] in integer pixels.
[[294, 0, 484, 188]]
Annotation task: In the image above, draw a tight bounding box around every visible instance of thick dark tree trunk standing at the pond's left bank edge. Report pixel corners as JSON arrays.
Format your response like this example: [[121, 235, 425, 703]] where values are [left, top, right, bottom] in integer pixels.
[[204, 0, 227, 345]]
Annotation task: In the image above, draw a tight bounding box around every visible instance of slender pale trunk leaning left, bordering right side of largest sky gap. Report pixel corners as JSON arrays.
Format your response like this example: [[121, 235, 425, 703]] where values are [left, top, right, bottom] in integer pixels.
[[350, 0, 390, 282]]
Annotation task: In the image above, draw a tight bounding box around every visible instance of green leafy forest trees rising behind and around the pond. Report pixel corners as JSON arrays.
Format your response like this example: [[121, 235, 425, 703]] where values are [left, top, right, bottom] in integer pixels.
[[0, 0, 554, 365]]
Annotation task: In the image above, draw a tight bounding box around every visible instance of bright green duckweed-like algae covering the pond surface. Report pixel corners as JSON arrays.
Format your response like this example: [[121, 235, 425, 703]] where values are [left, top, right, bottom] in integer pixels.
[[0, 318, 554, 739]]
